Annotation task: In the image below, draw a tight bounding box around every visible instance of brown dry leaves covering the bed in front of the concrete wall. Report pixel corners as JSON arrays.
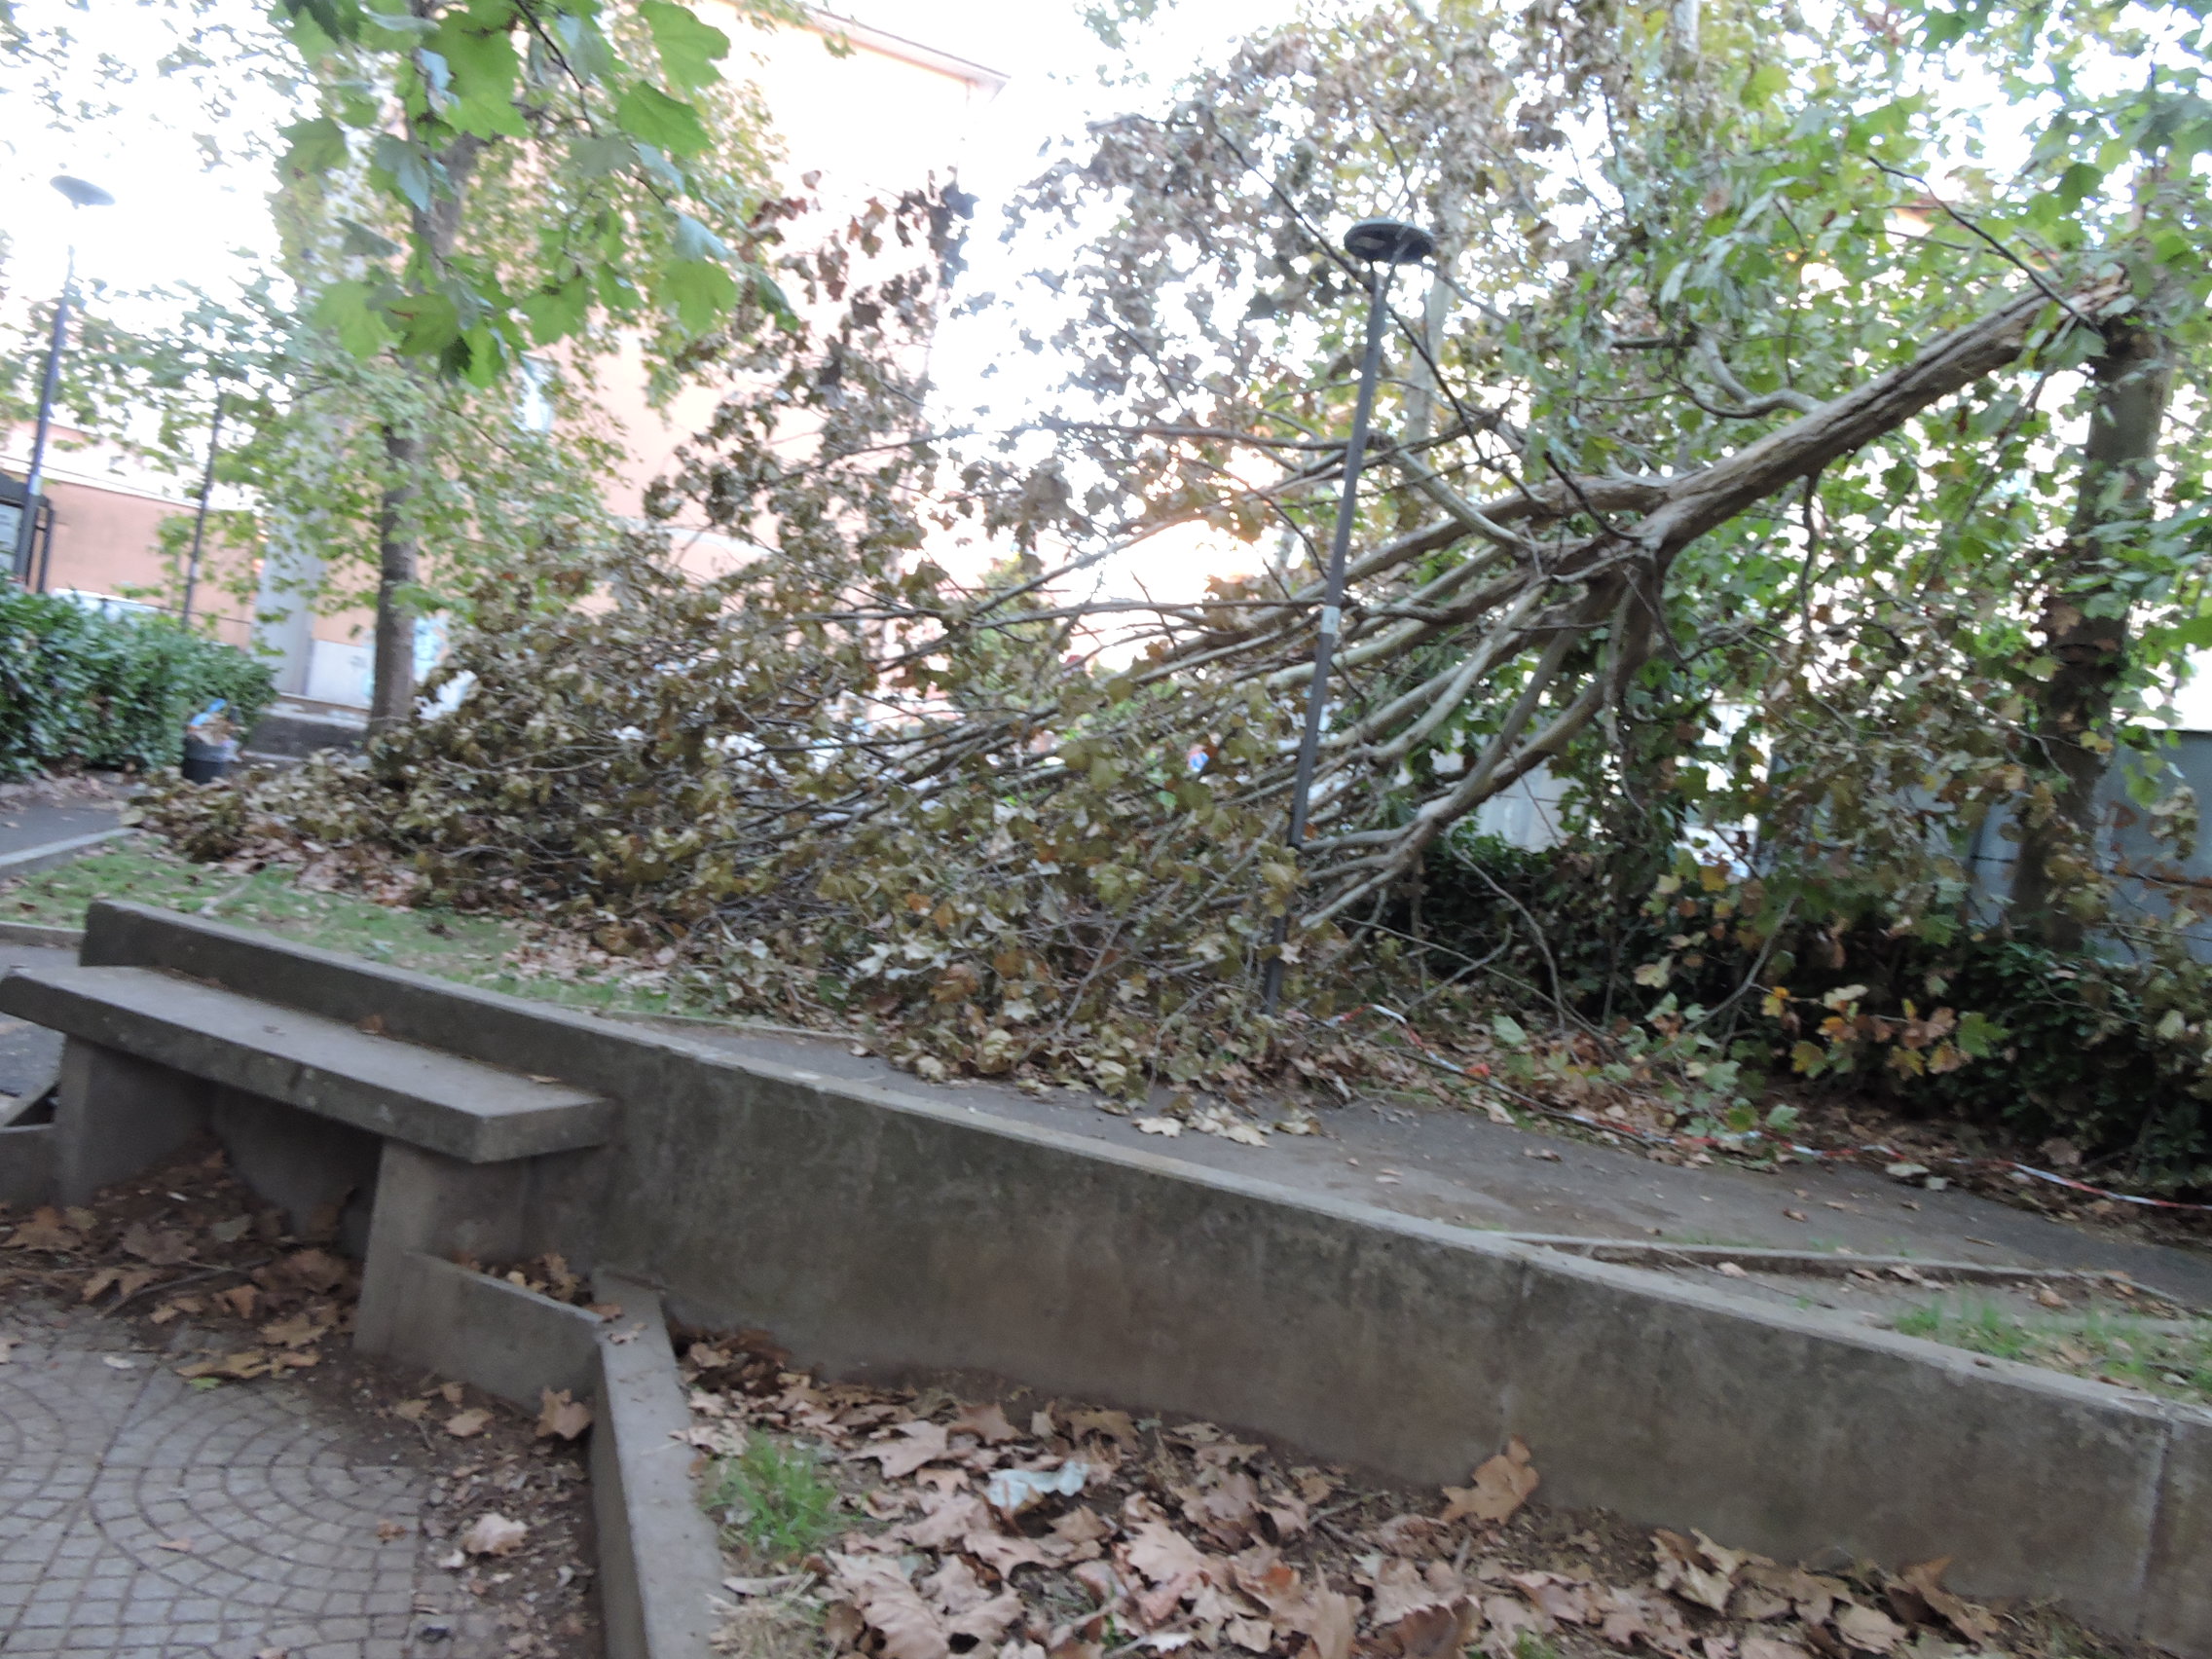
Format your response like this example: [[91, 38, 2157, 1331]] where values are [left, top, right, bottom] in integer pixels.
[[683, 1334, 2070, 1659]]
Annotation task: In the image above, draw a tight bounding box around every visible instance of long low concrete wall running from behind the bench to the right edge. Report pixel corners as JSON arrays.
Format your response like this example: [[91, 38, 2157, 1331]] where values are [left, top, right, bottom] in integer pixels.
[[55, 904, 2212, 1657]]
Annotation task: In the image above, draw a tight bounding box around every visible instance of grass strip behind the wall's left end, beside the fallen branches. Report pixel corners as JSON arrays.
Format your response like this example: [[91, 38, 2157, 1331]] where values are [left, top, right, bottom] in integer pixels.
[[0, 836, 706, 1014]]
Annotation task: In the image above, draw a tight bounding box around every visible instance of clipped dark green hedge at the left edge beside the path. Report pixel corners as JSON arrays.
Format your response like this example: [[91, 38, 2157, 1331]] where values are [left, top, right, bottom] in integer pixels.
[[0, 582, 276, 779]]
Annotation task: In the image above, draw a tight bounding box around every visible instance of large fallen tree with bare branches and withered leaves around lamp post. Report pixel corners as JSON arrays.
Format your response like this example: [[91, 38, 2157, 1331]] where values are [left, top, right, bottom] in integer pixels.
[[147, 5, 2212, 1194]]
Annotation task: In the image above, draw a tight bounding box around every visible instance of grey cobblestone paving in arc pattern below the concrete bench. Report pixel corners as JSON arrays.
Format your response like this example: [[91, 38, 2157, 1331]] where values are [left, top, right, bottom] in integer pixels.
[[0, 1308, 433, 1659]]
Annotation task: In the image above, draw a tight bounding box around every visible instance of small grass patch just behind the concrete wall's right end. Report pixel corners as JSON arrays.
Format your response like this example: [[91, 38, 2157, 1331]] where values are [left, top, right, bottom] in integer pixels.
[[1892, 1299, 2212, 1405]]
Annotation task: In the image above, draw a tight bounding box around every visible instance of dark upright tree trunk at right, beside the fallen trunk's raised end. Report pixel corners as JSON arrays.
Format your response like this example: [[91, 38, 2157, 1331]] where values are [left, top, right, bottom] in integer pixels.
[[2010, 316, 2174, 951]]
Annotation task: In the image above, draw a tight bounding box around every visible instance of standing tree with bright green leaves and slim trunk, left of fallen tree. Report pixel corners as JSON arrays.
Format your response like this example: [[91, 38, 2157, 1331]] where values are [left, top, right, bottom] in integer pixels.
[[275, 0, 794, 730]]
